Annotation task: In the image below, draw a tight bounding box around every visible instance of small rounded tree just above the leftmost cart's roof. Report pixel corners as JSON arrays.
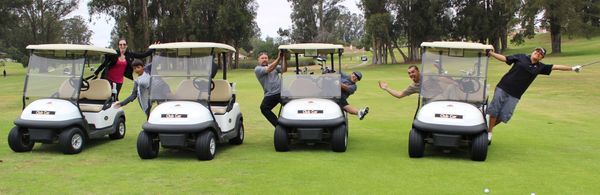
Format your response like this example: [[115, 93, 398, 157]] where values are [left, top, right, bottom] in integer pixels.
[[62, 16, 93, 44]]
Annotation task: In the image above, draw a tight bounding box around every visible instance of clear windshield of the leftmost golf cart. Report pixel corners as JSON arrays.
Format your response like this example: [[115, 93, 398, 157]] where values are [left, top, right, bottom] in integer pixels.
[[25, 53, 85, 100]]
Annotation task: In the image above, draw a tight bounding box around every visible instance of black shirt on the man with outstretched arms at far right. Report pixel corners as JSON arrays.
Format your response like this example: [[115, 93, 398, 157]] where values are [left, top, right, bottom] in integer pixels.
[[498, 54, 553, 99]]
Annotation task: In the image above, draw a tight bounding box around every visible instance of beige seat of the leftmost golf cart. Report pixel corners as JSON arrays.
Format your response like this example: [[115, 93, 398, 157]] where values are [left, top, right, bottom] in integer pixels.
[[79, 79, 112, 112]]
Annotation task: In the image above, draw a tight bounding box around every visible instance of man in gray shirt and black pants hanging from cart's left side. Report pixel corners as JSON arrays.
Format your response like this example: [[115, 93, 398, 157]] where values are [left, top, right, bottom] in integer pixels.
[[254, 52, 287, 127]]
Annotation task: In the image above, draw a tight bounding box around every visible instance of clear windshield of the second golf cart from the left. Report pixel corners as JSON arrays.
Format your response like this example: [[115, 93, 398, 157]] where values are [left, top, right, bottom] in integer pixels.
[[150, 53, 216, 101]]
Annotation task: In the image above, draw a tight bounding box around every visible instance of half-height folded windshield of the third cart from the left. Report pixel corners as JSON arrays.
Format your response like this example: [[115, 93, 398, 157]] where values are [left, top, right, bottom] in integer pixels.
[[281, 73, 341, 99]]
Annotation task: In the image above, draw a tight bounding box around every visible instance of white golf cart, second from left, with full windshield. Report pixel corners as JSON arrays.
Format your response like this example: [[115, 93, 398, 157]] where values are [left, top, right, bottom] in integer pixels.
[[137, 42, 244, 160]]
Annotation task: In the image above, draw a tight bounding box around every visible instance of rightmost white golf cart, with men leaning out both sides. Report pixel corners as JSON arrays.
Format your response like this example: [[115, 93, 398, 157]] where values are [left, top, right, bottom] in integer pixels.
[[408, 42, 493, 161]]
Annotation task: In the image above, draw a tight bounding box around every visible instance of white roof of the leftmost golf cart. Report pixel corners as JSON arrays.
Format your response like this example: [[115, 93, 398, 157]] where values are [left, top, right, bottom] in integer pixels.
[[26, 44, 117, 55]]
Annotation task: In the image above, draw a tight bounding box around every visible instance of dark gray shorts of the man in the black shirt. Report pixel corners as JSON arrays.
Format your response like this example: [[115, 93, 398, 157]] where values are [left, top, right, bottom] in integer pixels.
[[487, 87, 519, 123]]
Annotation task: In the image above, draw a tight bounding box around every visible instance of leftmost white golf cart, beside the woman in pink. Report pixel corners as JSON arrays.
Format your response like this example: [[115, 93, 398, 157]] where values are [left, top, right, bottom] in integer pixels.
[[8, 44, 125, 154]]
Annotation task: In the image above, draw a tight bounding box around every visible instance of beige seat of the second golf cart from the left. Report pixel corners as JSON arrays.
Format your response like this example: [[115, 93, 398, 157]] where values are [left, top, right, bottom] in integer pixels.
[[210, 80, 235, 114]]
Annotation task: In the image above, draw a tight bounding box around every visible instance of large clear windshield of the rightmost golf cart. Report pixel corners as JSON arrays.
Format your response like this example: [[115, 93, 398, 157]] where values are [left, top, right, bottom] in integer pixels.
[[421, 47, 488, 104]]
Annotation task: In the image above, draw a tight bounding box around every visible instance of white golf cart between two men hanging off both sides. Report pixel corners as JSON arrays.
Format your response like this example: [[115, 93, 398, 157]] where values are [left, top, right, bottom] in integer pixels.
[[274, 43, 348, 152]]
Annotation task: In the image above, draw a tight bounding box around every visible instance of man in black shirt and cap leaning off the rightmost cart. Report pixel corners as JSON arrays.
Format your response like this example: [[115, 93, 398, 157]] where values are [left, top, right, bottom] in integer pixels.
[[487, 47, 582, 142]]
